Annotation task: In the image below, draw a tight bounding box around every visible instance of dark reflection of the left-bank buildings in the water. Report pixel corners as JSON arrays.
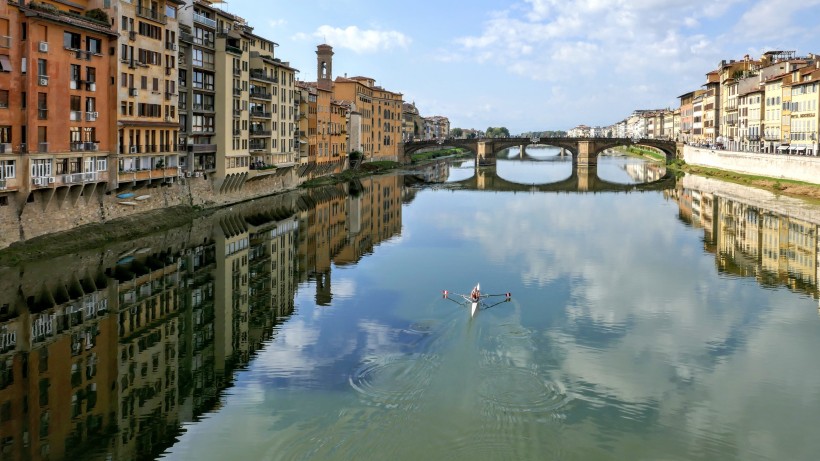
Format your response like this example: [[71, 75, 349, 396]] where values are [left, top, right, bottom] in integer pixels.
[[0, 176, 403, 460]]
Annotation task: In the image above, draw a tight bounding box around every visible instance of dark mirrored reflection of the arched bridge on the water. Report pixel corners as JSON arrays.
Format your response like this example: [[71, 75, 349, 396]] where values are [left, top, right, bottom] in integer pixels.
[[443, 162, 676, 192]]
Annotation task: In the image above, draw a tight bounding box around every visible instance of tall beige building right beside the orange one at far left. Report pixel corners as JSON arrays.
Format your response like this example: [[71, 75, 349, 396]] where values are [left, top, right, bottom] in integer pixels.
[[100, 0, 182, 188]]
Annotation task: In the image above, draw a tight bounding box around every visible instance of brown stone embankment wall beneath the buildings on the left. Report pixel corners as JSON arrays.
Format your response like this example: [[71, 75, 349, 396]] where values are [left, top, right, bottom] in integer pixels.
[[0, 168, 304, 249]]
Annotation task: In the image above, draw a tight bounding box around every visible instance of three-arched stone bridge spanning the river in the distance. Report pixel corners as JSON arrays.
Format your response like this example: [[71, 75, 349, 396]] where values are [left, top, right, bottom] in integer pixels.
[[404, 138, 683, 165]]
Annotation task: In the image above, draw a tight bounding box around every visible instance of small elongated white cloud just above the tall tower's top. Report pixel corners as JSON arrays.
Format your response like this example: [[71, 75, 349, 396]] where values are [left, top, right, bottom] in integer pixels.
[[294, 25, 412, 53]]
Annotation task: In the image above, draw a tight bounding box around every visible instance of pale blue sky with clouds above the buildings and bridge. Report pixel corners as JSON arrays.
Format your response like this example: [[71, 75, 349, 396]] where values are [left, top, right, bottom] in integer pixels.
[[216, 0, 820, 134]]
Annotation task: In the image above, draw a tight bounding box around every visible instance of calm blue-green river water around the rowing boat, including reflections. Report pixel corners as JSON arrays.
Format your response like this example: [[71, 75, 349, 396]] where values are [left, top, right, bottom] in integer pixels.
[[0, 149, 820, 460]]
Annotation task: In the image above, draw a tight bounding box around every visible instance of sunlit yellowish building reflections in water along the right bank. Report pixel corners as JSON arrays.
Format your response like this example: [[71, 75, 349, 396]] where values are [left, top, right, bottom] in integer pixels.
[[667, 178, 820, 299]]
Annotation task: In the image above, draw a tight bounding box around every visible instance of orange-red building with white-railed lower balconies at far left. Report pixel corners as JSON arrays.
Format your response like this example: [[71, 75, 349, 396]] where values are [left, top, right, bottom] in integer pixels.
[[0, 0, 117, 206]]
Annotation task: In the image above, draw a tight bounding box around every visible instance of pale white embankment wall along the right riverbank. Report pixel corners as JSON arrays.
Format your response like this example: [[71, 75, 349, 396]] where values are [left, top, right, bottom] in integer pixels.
[[683, 146, 820, 184]]
